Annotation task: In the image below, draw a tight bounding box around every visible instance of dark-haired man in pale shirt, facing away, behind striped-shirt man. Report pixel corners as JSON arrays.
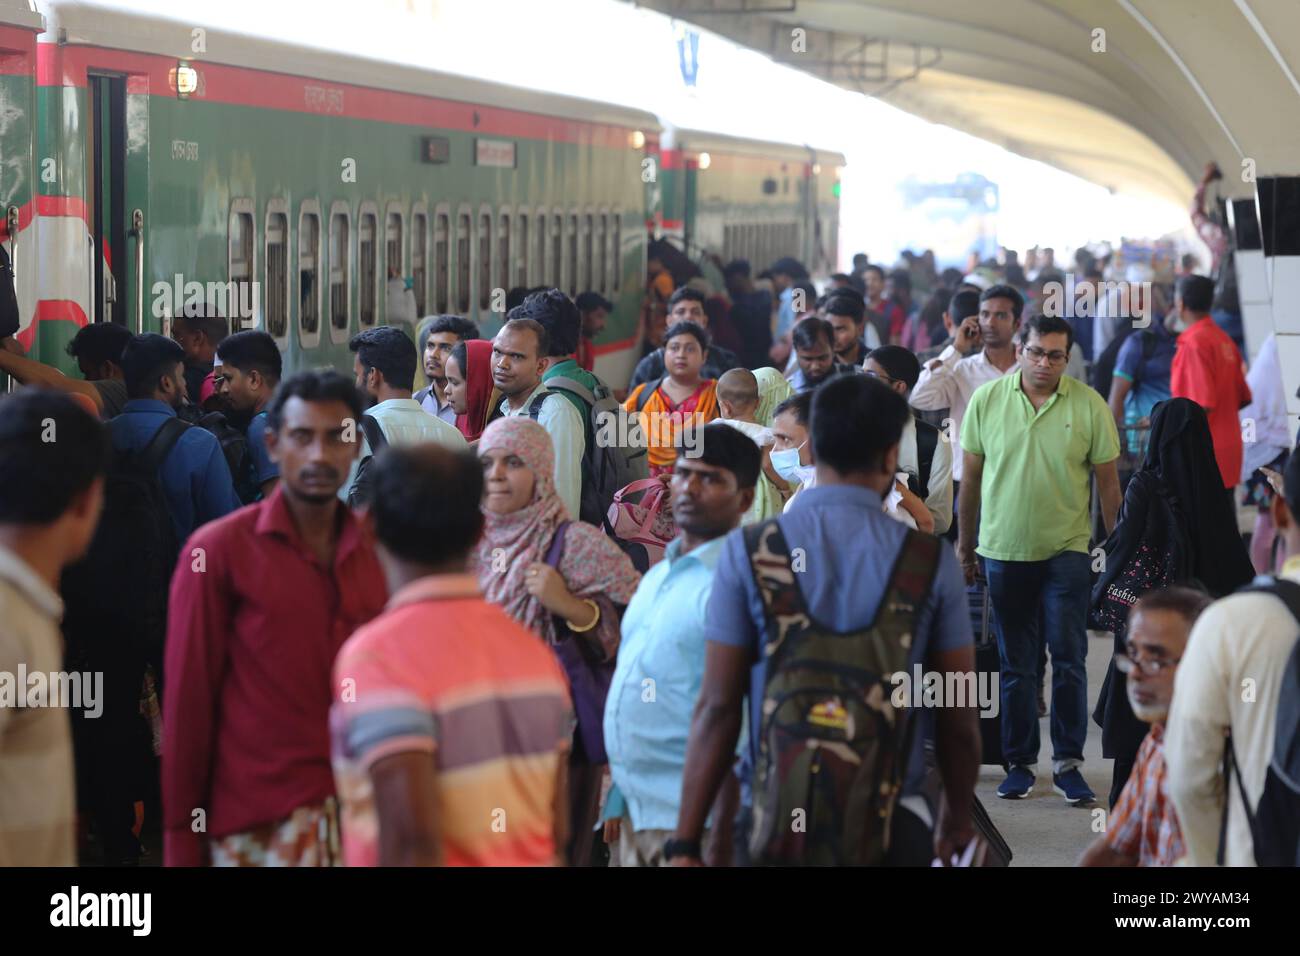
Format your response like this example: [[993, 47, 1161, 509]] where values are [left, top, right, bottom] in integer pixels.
[[339, 325, 467, 503]]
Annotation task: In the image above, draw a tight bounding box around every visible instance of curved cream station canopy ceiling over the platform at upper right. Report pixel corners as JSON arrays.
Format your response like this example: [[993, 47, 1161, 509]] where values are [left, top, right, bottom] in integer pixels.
[[624, 0, 1300, 203]]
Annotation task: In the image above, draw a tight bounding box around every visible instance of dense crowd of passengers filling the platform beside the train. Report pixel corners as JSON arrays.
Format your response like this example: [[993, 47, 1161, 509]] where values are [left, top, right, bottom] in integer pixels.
[[0, 196, 1300, 866]]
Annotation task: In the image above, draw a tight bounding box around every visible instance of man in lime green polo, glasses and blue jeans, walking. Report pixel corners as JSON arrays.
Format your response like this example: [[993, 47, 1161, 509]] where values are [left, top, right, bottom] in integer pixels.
[[957, 315, 1121, 804]]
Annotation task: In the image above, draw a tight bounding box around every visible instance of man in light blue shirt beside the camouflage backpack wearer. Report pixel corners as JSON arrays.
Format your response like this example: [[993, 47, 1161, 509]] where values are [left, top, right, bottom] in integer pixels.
[[605, 424, 762, 866]]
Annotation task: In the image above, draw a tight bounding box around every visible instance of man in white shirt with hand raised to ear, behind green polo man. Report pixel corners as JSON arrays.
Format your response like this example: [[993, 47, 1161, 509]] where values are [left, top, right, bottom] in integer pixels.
[[910, 285, 1024, 483]]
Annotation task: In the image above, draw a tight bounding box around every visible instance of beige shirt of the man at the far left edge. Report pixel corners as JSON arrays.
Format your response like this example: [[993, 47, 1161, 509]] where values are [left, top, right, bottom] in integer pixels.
[[0, 546, 77, 866]]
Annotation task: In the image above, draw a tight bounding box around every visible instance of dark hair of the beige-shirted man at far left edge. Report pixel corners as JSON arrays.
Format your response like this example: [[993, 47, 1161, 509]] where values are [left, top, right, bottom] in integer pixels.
[[0, 390, 110, 524]]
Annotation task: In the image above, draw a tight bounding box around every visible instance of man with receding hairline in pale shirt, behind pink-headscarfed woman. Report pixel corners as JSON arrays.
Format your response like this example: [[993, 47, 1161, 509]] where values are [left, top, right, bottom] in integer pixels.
[[491, 319, 586, 520]]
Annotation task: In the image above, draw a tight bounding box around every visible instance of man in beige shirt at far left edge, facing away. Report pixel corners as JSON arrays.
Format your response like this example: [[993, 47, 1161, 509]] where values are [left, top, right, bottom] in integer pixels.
[[0, 389, 109, 868]]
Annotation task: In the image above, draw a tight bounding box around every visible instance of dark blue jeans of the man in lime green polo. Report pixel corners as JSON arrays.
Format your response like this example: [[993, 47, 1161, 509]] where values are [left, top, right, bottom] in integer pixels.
[[984, 551, 1092, 773]]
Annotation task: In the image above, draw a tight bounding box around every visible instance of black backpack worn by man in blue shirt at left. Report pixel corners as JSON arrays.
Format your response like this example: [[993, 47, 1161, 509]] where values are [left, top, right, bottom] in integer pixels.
[[61, 418, 190, 672]]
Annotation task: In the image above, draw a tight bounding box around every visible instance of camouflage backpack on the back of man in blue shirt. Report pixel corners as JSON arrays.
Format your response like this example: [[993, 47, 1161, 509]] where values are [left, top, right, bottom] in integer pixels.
[[745, 519, 940, 866]]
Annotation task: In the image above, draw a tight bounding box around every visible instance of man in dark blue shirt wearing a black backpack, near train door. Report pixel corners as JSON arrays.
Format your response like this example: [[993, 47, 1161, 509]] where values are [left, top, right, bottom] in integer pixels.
[[108, 332, 241, 541]]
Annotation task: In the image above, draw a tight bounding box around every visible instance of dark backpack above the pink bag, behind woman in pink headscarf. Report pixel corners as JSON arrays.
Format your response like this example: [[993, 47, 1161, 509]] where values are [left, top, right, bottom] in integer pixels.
[[528, 376, 650, 533]]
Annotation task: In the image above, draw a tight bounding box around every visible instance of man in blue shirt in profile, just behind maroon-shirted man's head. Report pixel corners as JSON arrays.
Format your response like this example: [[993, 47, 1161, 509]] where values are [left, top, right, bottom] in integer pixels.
[[216, 329, 281, 503]]
